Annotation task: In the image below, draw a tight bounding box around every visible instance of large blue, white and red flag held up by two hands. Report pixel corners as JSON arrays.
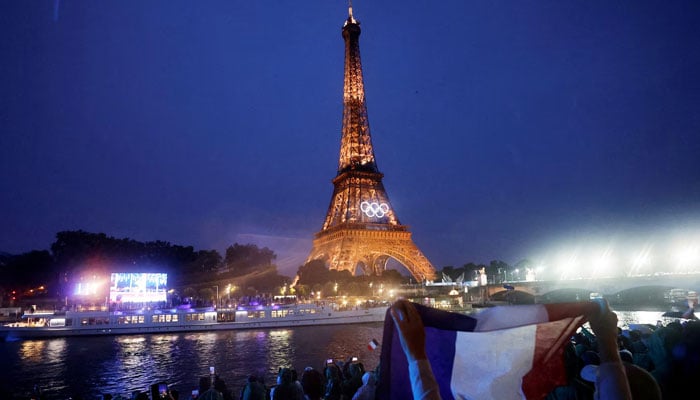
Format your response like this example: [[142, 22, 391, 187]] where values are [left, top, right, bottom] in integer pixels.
[[376, 302, 599, 400]]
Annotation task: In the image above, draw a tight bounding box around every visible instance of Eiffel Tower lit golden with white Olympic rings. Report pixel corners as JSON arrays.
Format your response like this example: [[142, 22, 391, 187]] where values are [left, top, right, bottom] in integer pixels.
[[307, 4, 435, 281]]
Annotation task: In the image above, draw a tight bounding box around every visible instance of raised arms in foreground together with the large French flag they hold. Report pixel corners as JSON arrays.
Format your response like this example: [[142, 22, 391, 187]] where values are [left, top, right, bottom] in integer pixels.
[[377, 300, 630, 400]]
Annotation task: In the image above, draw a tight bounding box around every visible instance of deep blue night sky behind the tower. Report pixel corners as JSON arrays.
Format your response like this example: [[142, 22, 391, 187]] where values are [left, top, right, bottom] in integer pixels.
[[0, 0, 700, 272]]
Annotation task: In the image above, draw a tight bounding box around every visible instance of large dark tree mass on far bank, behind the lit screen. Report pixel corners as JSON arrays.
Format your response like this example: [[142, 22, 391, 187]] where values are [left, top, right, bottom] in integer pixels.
[[0, 230, 290, 299]]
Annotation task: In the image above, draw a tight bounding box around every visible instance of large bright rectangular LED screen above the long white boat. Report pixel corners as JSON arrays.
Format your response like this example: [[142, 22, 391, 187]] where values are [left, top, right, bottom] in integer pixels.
[[109, 272, 168, 303]]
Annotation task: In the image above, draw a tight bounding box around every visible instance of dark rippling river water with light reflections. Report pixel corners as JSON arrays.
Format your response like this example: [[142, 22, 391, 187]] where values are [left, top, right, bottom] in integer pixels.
[[0, 311, 680, 400]]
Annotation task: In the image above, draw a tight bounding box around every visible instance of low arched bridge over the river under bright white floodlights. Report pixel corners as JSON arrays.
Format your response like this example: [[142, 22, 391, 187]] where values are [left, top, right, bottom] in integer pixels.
[[469, 273, 700, 301]]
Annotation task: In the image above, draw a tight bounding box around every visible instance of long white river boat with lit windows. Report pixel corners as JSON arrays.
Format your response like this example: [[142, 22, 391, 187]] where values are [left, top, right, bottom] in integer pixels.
[[0, 303, 387, 341]]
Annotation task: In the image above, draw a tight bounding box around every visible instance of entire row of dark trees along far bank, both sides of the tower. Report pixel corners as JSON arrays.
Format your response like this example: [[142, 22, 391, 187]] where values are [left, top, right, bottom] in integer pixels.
[[0, 230, 526, 302]]
